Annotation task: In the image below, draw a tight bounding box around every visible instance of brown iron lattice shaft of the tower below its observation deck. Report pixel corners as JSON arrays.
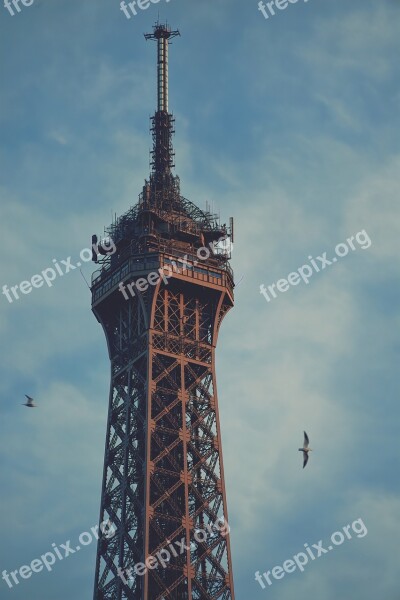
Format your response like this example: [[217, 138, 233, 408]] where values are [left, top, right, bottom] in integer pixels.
[[94, 278, 234, 600]]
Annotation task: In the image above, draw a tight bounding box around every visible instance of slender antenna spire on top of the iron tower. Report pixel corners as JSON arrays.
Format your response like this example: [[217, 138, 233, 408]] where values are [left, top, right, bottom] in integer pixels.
[[144, 22, 180, 188]]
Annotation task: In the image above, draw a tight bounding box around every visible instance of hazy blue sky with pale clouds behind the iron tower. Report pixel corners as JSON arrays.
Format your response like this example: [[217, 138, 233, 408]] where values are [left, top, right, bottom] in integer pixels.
[[0, 0, 400, 600]]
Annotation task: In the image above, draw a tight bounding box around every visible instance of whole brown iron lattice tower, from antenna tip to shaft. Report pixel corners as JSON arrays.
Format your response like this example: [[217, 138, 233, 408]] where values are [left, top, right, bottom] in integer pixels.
[[91, 23, 234, 600]]
